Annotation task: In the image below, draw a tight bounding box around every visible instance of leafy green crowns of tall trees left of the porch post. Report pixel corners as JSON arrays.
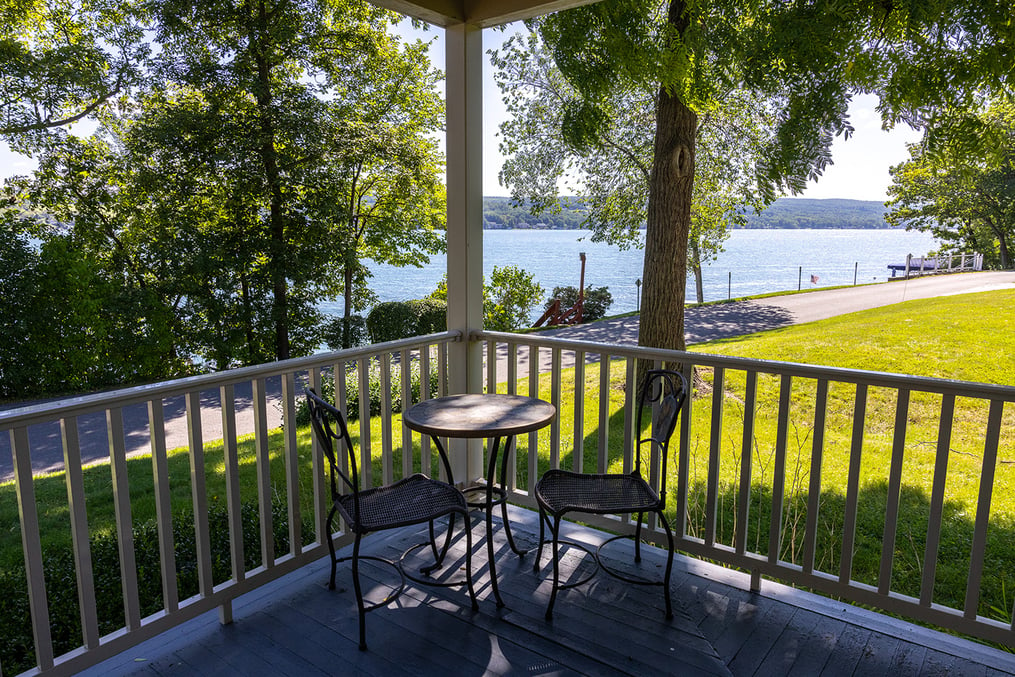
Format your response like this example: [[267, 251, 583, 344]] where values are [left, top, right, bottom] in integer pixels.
[[0, 0, 445, 369]]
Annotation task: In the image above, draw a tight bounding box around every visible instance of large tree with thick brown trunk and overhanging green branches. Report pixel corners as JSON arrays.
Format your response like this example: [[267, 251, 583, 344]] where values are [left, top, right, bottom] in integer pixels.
[[515, 0, 1015, 348]]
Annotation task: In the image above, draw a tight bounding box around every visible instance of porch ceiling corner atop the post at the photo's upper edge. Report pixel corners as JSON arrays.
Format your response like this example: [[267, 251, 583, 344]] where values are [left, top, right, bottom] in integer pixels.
[[371, 0, 597, 28]]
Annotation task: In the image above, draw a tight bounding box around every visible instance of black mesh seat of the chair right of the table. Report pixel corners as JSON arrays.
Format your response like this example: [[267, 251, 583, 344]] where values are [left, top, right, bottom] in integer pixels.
[[535, 470, 659, 515]]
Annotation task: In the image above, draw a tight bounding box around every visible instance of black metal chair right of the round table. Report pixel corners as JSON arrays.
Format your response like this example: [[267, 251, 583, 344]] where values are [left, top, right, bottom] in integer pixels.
[[533, 369, 687, 620]]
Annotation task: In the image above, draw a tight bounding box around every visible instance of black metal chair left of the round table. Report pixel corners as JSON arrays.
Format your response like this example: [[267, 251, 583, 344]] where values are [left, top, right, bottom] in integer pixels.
[[306, 388, 479, 651]]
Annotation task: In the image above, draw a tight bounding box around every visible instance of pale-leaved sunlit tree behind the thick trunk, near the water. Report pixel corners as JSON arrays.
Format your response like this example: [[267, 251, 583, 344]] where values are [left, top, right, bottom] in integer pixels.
[[491, 32, 771, 302]]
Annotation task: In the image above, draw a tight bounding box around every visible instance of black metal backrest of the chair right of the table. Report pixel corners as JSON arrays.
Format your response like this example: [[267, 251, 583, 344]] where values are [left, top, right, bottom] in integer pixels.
[[634, 369, 687, 497]]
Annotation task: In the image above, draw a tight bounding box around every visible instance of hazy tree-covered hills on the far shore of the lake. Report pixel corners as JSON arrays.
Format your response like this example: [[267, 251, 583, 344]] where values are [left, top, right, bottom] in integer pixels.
[[483, 196, 888, 230]]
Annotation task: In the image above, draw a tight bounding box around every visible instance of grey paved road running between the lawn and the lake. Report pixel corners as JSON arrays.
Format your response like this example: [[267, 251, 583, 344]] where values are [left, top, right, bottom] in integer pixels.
[[0, 272, 1015, 481]]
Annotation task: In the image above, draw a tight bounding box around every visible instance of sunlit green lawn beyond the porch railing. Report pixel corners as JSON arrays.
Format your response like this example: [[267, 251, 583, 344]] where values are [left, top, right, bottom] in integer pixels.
[[0, 291, 1015, 669]]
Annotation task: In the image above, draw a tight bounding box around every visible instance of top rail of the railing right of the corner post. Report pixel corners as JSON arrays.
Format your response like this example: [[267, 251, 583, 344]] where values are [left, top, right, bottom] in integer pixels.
[[469, 331, 1015, 402]]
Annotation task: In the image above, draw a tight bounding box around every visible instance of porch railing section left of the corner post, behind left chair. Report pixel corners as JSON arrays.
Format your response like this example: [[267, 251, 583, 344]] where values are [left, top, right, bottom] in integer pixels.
[[0, 333, 460, 675]]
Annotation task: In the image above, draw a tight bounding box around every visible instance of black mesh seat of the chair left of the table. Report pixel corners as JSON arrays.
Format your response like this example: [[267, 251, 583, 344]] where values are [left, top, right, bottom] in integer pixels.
[[336, 473, 468, 533]]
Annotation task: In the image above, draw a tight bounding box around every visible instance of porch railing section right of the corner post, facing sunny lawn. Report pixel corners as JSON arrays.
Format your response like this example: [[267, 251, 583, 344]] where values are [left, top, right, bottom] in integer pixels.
[[472, 332, 1015, 647]]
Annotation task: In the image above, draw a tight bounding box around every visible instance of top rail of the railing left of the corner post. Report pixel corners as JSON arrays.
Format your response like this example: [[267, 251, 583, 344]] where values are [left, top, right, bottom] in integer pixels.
[[0, 331, 462, 430]]
